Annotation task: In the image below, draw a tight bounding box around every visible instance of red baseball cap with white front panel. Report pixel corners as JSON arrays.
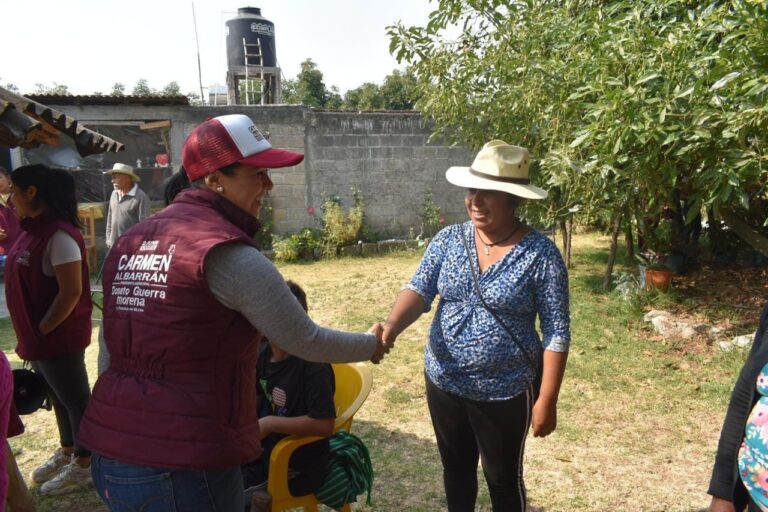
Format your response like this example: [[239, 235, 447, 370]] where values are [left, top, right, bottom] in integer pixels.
[[181, 114, 304, 181]]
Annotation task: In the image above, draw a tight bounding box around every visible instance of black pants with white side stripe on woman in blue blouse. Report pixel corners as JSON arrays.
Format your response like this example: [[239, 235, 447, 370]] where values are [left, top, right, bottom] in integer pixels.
[[426, 377, 533, 512]]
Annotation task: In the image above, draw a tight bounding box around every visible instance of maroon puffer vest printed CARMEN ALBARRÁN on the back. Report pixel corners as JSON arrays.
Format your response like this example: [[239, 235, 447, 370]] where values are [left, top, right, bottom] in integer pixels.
[[79, 190, 261, 469]]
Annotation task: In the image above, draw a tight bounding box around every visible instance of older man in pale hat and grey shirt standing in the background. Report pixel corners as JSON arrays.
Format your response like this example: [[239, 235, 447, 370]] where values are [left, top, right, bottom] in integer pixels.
[[104, 164, 150, 248]]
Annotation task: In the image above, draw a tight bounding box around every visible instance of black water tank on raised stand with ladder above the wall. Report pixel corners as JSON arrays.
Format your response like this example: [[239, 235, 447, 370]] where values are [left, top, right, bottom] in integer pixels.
[[225, 7, 281, 105]]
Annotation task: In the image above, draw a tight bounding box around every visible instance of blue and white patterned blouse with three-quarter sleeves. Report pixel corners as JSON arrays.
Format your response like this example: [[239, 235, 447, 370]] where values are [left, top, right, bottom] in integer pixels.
[[406, 222, 570, 401]]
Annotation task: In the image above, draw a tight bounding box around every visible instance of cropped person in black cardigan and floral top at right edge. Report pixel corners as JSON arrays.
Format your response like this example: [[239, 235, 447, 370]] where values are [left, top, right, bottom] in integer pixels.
[[707, 304, 768, 512]]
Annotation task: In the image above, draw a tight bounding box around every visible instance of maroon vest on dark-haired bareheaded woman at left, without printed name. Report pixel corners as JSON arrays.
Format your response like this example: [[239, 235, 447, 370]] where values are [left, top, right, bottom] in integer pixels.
[[5, 214, 93, 361]]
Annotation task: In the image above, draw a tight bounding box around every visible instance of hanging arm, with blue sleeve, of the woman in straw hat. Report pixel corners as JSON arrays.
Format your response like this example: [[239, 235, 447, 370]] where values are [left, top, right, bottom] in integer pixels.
[[531, 244, 571, 437]]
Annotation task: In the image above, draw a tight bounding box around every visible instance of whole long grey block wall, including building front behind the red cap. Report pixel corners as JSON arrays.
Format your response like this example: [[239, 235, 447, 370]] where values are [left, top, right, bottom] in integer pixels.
[[43, 105, 473, 240]]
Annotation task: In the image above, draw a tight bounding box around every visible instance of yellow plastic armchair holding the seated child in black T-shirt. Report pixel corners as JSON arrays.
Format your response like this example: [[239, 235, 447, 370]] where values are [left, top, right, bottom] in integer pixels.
[[267, 363, 373, 512]]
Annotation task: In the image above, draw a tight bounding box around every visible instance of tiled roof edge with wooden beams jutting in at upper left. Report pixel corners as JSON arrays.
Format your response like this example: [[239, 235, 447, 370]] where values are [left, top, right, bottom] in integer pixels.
[[0, 87, 125, 156]]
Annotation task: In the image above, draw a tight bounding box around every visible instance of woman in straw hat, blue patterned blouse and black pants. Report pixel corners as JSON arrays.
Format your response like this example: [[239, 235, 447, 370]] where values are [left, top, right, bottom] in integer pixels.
[[384, 140, 570, 512]]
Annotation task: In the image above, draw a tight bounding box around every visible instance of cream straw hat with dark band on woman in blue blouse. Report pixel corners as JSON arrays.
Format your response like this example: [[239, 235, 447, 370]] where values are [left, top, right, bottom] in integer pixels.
[[445, 140, 547, 199]]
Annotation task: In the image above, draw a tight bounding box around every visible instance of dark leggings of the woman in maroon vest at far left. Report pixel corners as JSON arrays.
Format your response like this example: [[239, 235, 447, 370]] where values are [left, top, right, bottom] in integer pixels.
[[31, 350, 91, 457]]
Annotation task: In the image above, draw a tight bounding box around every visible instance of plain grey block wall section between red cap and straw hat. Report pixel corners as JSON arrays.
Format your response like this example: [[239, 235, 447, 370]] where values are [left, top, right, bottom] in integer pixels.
[[306, 111, 473, 236]]
